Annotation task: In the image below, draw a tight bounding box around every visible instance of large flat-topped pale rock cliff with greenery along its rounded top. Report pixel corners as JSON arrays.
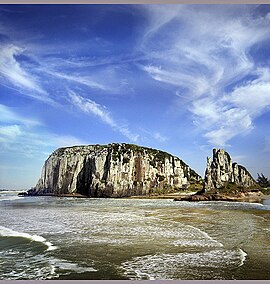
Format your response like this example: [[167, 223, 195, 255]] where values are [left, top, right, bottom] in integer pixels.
[[29, 144, 201, 197]]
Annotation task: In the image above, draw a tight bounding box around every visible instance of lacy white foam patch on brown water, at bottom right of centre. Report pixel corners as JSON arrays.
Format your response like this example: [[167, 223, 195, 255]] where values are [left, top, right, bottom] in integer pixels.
[[121, 249, 247, 280]]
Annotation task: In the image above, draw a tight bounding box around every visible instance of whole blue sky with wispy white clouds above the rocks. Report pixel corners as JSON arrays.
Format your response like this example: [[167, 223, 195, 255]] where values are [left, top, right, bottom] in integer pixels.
[[0, 4, 270, 189]]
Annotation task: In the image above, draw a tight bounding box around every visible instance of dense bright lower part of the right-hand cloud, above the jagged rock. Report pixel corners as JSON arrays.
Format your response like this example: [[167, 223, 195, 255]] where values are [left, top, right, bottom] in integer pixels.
[[200, 67, 270, 146]]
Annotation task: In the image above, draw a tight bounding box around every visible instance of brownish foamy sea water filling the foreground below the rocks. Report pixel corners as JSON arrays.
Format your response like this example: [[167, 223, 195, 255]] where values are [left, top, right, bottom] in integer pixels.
[[0, 191, 270, 280]]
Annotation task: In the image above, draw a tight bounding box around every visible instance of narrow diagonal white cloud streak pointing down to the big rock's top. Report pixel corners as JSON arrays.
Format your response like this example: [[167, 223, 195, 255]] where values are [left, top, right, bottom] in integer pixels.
[[68, 90, 139, 142]]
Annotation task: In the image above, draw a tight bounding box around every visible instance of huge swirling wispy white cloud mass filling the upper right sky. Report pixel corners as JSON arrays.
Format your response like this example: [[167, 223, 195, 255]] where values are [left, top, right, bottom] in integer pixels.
[[140, 5, 270, 146]]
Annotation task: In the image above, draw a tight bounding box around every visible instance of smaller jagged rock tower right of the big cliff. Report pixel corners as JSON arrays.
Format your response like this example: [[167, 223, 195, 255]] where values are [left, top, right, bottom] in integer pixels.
[[204, 149, 256, 190]]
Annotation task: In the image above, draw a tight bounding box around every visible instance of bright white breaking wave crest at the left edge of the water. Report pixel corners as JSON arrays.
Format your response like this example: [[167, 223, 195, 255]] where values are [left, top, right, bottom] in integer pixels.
[[0, 226, 57, 251]]
